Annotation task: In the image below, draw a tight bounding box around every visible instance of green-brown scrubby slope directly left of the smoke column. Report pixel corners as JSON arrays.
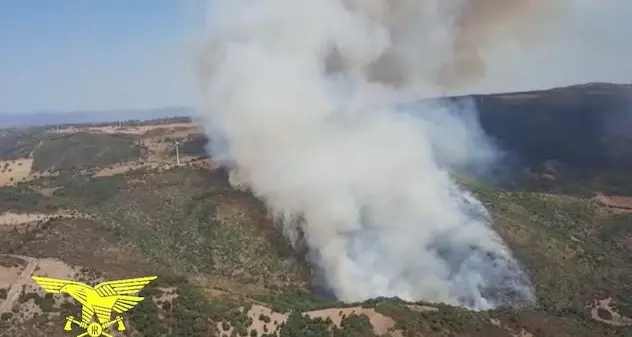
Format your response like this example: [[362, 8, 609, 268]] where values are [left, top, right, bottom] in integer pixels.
[[55, 167, 304, 283]]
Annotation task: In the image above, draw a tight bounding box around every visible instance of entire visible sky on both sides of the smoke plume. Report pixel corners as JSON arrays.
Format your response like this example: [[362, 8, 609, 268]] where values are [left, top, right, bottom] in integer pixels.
[[0, 0, 632, 114]]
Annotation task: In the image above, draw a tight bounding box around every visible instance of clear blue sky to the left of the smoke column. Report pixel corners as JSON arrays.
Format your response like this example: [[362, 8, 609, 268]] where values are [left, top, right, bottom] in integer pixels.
[[0, 0, 201, 112]]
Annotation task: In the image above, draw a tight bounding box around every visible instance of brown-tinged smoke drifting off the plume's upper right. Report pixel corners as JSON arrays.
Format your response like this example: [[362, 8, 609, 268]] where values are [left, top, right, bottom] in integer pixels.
[[336, 0, 567, 91]]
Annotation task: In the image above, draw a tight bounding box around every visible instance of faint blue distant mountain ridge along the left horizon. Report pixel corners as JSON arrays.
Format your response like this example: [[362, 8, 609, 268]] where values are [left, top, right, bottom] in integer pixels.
[[0, 106, 193, 127]]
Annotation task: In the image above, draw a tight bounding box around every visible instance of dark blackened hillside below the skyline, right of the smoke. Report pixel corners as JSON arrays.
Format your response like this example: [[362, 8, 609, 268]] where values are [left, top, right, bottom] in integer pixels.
[[474, 84, 632, 169]]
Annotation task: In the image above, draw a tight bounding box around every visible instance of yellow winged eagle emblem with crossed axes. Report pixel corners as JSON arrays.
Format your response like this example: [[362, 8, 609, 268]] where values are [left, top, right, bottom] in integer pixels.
[[33, 276, 158, 337]]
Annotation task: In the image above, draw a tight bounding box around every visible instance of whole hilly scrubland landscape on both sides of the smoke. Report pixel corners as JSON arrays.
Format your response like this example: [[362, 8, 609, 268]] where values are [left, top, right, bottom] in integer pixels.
[[0, 84, 632, 337]]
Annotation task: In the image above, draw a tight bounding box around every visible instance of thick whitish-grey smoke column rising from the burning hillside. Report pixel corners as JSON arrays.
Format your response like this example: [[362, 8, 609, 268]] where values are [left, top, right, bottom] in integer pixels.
[[198, 0, 537, 309]]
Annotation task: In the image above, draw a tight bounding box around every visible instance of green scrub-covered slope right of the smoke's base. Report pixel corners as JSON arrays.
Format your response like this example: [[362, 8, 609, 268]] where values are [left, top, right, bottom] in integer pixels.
[[475, 186, 632, 311]]
